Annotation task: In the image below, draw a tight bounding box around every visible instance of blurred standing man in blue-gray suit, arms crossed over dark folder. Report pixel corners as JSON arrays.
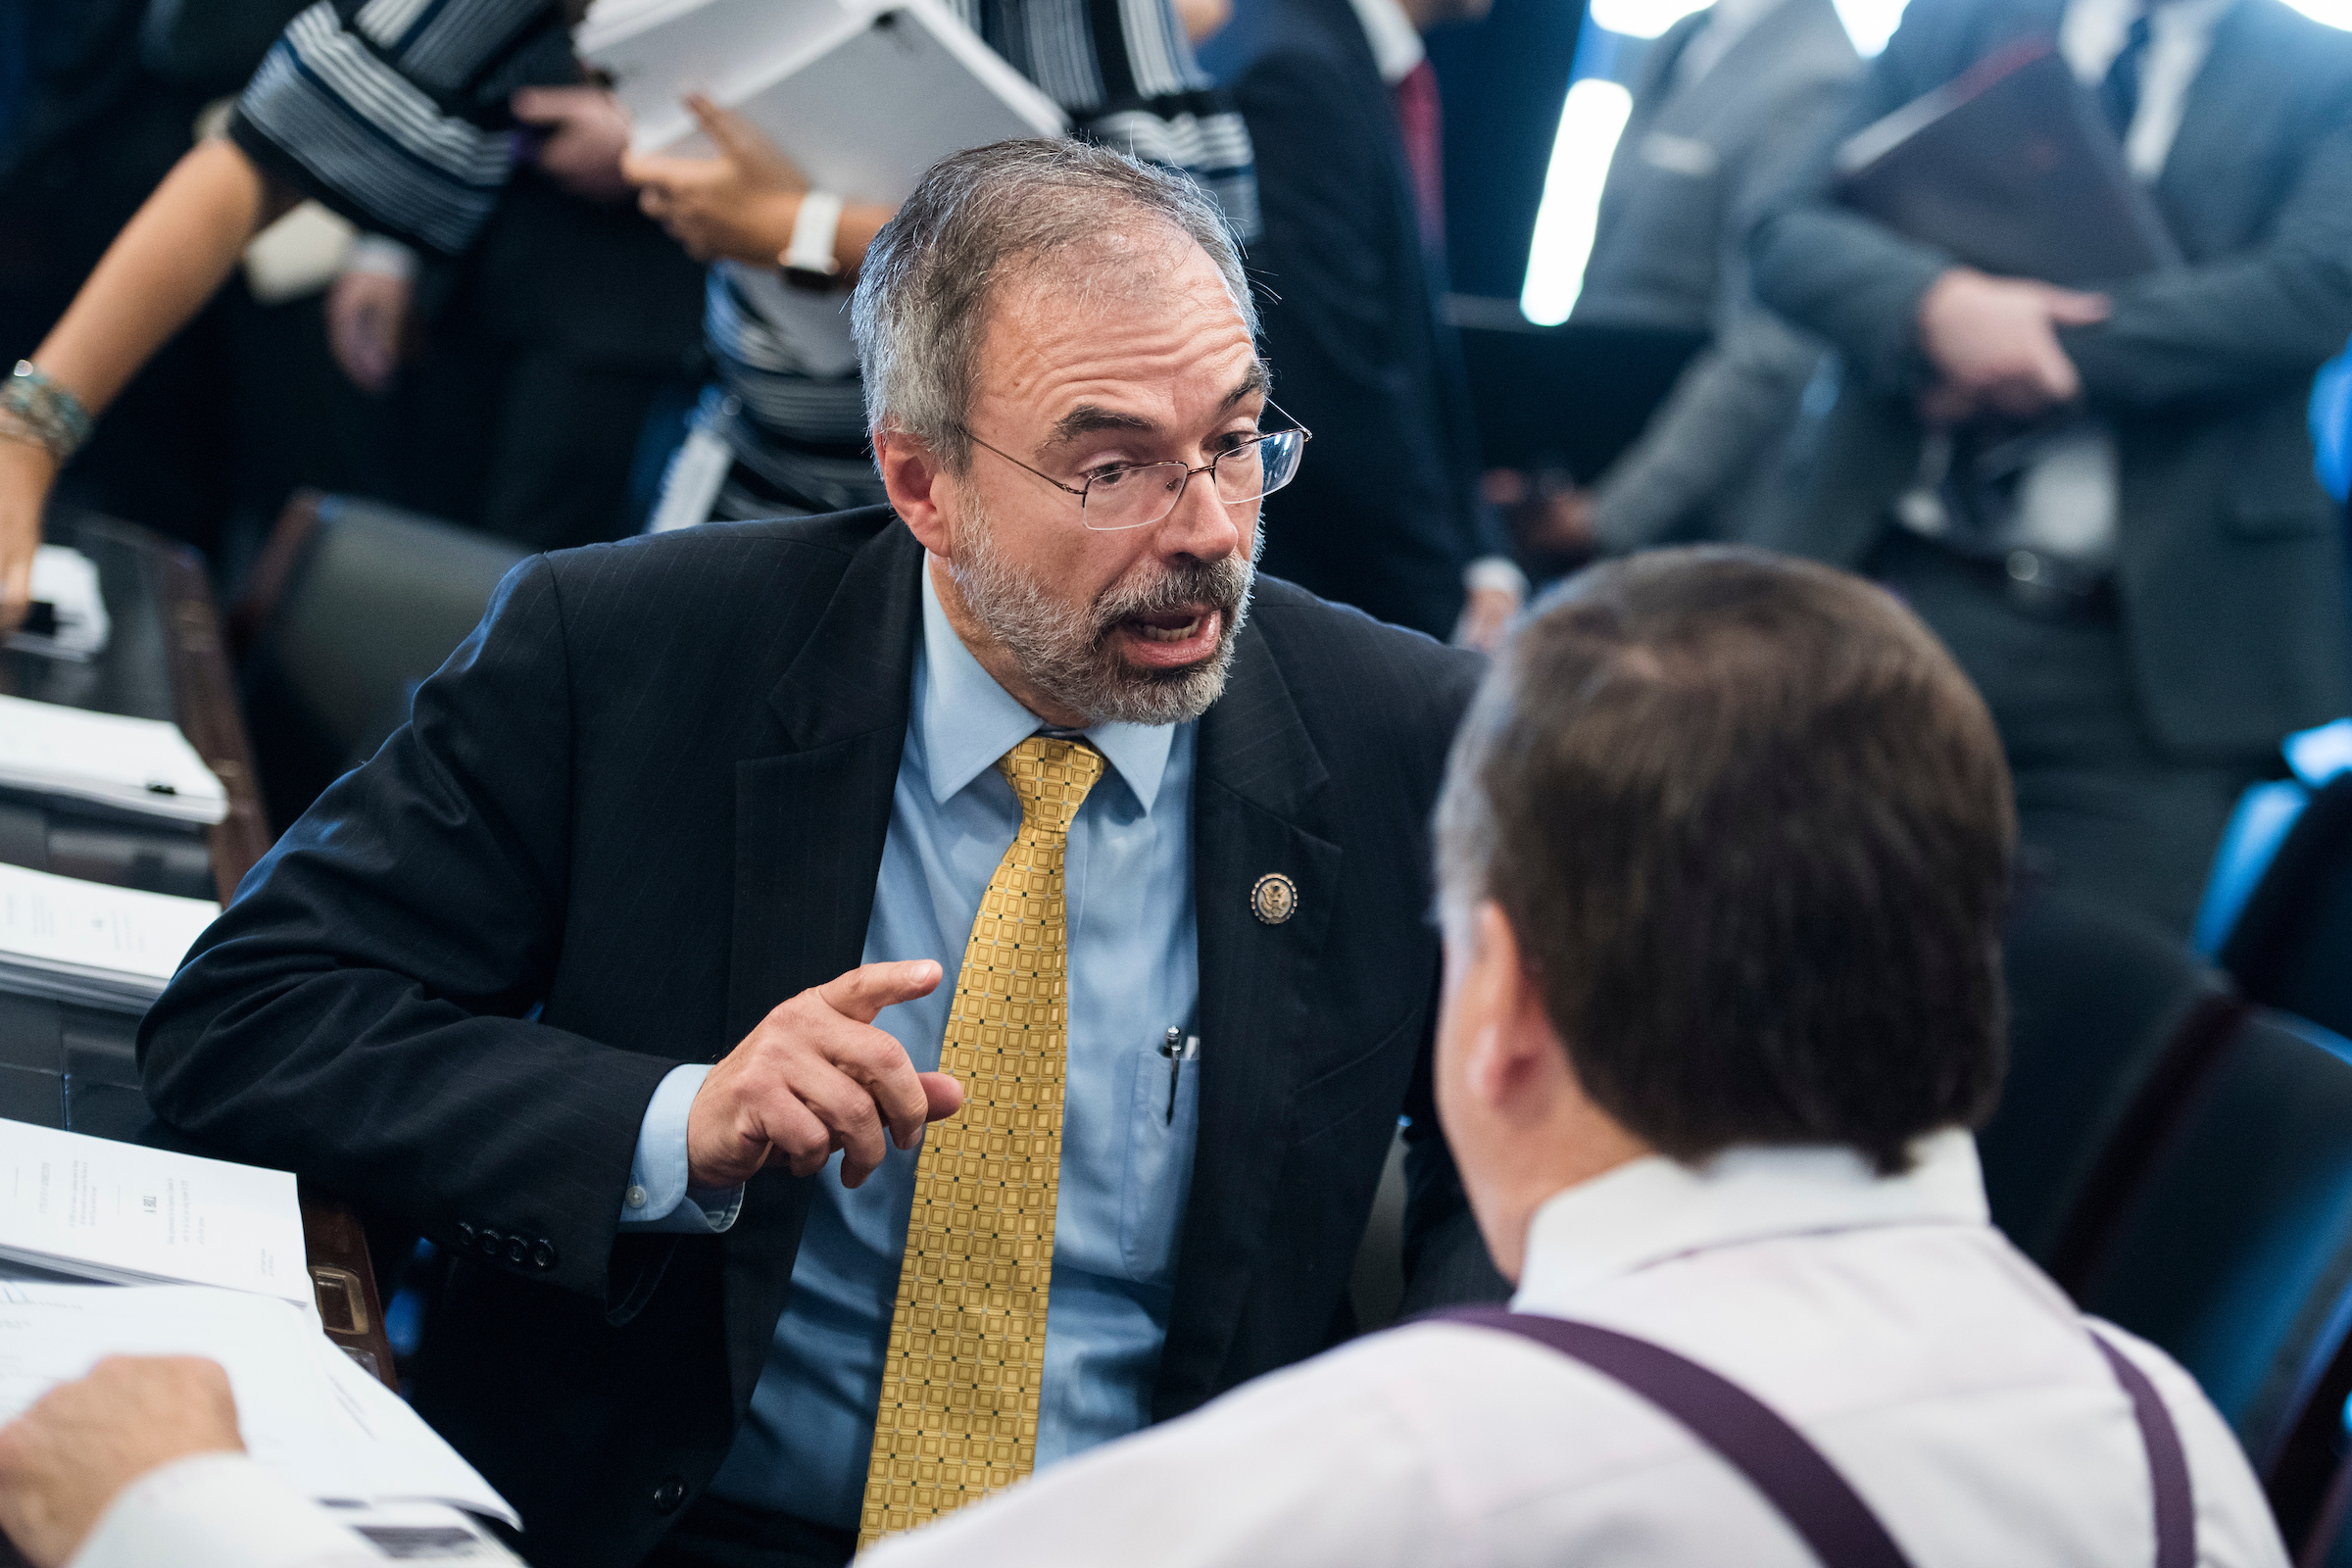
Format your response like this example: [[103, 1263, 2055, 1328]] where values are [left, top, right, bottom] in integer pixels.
[[1750, 0, 2352, 931]]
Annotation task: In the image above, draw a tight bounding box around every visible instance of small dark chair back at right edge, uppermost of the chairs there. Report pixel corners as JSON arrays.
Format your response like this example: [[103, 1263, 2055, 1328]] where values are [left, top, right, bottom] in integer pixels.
[[2221, 773, 2352, 1034]]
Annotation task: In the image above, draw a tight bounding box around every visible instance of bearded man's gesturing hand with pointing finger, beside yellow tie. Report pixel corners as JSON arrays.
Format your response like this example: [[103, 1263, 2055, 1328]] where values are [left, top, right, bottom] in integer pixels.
[[687, 959, 964, 1187]]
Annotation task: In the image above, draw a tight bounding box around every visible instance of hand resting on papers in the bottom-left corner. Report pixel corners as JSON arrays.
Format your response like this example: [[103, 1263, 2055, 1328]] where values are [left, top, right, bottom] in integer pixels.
[[0, 1356, 245, 1568]]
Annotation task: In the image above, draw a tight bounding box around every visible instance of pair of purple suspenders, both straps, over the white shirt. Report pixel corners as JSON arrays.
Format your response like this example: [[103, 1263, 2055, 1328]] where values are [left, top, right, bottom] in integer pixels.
[[1423, 1307, 2197, 1568]]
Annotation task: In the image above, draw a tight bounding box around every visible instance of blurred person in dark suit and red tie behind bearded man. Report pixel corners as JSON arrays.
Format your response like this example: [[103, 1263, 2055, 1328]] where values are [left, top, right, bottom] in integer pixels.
[[1201, 0, 1527, 647]]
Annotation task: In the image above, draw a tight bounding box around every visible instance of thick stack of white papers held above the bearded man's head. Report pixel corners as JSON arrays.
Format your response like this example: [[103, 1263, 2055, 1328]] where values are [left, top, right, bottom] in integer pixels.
[[578, 0, 1068, 207]]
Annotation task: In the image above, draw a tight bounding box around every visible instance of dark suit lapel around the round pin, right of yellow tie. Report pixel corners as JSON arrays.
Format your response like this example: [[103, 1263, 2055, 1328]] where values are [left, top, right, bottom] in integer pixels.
[[1152, 630, 1341, 1415]]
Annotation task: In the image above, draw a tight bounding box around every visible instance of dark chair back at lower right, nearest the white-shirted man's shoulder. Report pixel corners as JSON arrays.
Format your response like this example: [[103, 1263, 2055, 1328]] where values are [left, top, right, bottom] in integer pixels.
[[2065, 1008, 2352, 1561]]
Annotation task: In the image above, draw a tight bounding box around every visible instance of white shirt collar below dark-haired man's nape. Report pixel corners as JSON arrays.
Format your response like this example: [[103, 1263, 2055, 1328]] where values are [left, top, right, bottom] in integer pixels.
[[1510, 1128, 1987, 1312]]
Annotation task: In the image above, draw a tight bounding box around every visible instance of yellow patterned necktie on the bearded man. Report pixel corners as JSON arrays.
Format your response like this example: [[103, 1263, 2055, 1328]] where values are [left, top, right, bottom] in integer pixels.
[[858, 736, 1103, 1549]]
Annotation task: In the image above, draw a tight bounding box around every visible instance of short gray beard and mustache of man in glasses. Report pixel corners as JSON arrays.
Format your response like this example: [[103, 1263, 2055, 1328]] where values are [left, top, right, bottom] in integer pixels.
[[948, 508, 1260, 724]]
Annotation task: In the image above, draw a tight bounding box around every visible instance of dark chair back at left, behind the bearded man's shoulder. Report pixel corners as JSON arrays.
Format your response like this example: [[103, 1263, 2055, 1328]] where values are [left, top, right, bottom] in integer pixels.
[[230, 491, 529, 830]]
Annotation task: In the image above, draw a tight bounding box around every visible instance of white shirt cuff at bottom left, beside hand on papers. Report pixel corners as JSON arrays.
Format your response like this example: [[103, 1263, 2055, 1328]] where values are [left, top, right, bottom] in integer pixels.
[[66, 1452, 383, 1568]]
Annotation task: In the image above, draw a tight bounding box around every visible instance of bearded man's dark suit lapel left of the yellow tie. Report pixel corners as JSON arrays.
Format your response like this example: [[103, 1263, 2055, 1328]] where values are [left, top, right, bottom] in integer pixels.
[[724, 522, 922, 1410]]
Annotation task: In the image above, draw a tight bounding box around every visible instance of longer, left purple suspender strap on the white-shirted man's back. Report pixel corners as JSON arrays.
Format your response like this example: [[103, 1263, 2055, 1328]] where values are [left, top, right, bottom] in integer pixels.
[[1433, 1307, 1910, 1568]]
